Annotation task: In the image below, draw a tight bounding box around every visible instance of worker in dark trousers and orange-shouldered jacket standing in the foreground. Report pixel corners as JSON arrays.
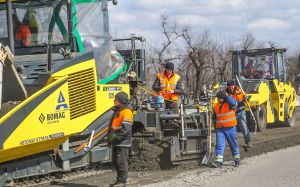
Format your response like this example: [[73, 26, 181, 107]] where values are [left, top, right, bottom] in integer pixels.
[[107, 92, 133, 187]]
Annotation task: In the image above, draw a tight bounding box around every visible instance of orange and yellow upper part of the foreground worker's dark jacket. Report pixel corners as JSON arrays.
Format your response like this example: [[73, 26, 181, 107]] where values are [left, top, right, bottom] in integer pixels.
[[111, 108, 133, 131]]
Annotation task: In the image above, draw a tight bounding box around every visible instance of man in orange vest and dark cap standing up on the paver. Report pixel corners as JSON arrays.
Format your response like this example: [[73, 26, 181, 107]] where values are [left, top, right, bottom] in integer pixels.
[[152, 62, 182, 111]]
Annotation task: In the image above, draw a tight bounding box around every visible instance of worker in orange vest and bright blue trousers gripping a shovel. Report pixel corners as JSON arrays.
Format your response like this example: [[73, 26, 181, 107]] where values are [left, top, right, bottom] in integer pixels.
[[211, 91, 240, 168]]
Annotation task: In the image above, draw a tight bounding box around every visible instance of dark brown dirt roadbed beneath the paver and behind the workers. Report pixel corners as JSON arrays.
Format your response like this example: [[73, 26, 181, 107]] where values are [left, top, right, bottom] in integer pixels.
[[47, 112, 300, 187]]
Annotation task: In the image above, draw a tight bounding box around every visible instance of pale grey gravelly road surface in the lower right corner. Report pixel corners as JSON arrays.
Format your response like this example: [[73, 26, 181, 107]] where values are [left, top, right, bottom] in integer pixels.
[[146, 146, 300, 187]]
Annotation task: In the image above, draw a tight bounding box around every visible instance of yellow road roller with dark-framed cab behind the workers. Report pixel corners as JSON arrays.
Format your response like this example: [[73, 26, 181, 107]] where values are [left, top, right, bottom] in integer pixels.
[[230, 48, 297, 131]]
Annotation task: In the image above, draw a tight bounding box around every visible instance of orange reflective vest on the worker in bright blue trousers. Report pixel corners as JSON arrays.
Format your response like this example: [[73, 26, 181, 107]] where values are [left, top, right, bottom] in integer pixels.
[[214, 102, 237, 128]]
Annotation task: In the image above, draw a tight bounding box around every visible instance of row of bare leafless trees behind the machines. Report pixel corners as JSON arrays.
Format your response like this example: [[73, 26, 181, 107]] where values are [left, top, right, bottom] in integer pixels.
[[146, 15, 300, 97]]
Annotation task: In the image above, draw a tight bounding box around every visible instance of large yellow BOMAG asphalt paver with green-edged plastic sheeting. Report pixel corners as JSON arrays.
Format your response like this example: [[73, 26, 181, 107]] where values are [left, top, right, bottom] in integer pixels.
[[0, 0, 209, 186]]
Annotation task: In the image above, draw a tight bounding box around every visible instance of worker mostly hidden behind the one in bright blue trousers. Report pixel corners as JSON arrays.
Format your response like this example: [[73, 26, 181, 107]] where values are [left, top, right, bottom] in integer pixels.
[[225, 81, 251, 148]]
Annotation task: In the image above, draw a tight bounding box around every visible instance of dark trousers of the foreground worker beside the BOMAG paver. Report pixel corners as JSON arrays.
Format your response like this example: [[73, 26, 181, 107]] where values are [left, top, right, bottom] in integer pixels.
[[112, 147, 129, 183]]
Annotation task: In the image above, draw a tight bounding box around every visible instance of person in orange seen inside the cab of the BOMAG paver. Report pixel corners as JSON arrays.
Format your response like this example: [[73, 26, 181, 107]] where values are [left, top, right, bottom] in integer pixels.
[[13, 14, 31, 47]]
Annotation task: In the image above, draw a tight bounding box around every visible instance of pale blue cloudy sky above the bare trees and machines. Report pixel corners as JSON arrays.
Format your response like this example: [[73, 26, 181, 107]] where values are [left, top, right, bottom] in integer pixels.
[[110, 0, 300, 50]]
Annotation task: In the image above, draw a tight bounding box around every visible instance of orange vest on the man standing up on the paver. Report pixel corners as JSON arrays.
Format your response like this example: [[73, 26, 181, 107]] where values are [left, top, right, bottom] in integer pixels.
[[157, 72, 180, 101]]
